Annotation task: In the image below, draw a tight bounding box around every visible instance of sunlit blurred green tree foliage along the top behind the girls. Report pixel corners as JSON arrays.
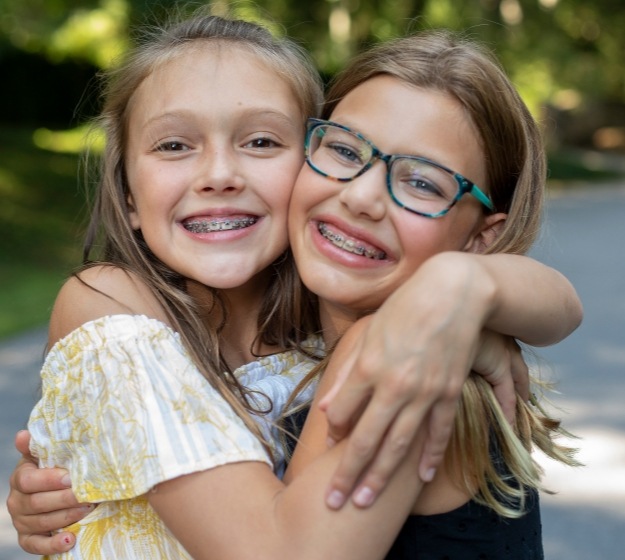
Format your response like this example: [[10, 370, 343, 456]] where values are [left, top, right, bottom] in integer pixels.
[[0, 0, 625, 137]]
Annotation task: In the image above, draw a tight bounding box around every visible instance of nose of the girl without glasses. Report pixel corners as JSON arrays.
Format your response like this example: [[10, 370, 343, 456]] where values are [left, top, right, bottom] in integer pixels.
[[195, 146, 245, 194]]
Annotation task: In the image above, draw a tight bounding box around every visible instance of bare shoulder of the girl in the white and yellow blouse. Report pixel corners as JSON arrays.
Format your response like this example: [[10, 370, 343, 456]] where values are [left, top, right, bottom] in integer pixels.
[[48, 265, 167, 346]]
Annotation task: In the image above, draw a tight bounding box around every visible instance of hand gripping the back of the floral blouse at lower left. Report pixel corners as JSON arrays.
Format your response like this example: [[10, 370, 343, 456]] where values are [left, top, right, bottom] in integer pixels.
[[7, 431, 94, 554]]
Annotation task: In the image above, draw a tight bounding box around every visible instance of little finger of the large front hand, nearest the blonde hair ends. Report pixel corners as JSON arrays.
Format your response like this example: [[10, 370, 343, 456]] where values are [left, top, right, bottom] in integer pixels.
[[419, 400, 456, 482]]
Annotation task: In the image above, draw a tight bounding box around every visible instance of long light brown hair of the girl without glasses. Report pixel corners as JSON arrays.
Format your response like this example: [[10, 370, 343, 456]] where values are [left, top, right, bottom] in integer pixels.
[[83, 10, 323, 450]]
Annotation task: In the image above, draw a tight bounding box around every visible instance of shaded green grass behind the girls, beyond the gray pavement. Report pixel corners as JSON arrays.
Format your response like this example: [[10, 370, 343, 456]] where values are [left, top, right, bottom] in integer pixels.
[[0, 125, 618, 339]]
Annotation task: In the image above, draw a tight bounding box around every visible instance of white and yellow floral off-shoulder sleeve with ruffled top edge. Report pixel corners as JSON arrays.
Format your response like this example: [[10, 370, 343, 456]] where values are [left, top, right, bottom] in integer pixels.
[[29, 315, 271, 502]]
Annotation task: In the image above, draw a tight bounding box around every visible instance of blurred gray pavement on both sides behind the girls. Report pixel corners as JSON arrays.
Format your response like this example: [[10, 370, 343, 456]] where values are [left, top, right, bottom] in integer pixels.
[[0, 184, 625, 560]]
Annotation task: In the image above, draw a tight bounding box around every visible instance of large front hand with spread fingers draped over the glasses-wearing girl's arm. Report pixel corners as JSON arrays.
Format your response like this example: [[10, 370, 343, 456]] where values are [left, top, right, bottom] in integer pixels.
[[320, 256, 522, 507]]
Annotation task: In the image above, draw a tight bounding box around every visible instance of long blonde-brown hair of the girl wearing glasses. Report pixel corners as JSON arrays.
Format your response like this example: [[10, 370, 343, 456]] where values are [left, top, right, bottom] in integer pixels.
[[314, 31, 578, 517]]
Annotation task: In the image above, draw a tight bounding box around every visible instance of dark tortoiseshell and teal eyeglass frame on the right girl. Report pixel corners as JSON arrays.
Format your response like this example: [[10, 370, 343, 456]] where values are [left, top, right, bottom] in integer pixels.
[[304, 117, 496, 218]]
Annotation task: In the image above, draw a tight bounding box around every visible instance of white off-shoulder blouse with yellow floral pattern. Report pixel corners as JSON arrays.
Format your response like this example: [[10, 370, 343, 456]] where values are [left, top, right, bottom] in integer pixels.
[[28, 315, 321, 560]]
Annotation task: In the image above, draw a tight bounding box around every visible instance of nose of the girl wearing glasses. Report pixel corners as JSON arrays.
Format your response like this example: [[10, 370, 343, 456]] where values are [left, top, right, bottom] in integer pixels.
[[339, 160, 388, 220]]
